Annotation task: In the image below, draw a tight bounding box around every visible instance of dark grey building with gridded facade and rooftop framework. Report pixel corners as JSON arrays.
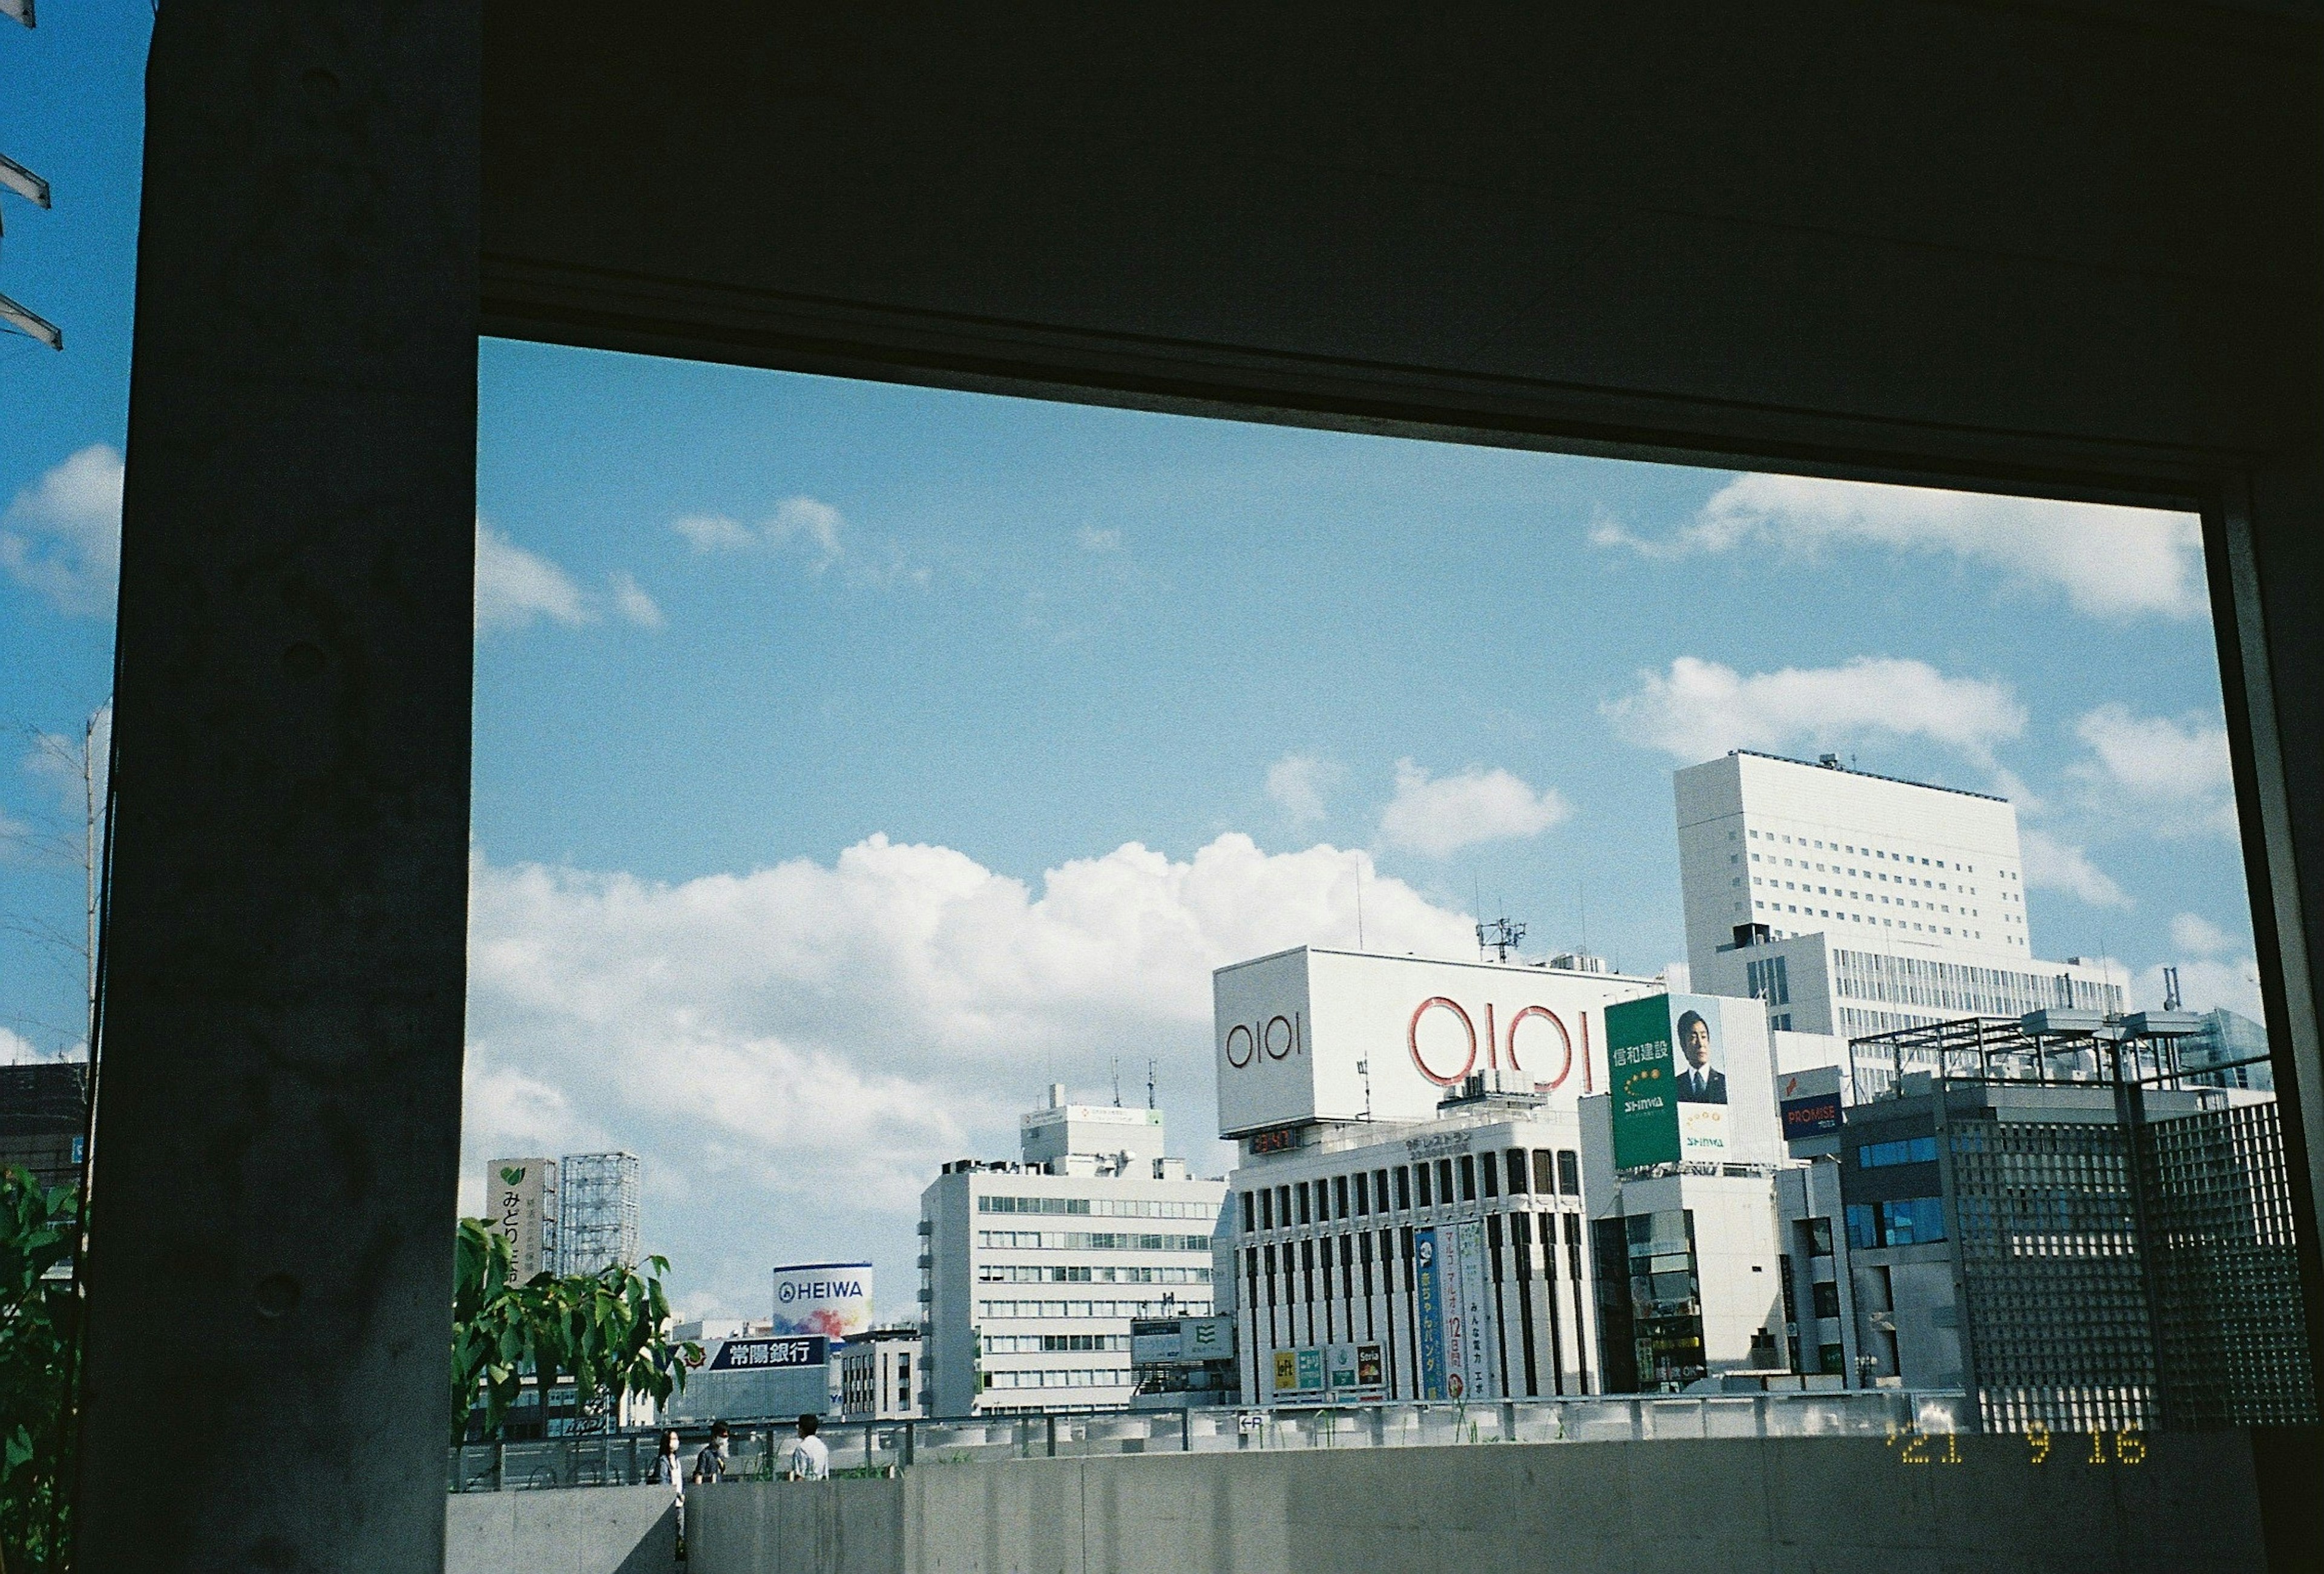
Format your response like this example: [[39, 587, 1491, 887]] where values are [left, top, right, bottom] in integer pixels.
[[1780, 1016, 2315, 1430]]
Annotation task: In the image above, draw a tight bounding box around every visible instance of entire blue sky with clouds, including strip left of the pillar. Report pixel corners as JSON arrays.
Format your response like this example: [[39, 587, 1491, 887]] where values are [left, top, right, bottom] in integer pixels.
[[0, 7, 2254, 1316]]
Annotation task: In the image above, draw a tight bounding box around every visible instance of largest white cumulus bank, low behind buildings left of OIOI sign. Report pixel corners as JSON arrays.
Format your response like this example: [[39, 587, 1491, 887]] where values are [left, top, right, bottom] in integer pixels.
[[462, 835, 1474, 1314]]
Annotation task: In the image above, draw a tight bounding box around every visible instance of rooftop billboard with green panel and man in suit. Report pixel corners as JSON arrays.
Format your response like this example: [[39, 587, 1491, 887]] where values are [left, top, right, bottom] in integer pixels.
[[1606, 995, 1776, 1170]]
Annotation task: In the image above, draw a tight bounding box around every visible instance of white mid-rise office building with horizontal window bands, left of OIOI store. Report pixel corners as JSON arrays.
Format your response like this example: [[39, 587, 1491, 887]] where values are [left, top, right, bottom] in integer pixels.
[[918, 1086, 1227, 1416]]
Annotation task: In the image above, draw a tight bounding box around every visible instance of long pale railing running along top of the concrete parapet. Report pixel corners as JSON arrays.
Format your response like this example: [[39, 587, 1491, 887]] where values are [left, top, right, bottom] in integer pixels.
[[448, 1388, 1975, 1493]]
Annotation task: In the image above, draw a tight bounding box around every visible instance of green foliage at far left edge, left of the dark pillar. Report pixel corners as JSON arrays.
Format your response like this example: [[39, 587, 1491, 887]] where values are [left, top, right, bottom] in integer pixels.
[[0, 1167, 81, 1569]]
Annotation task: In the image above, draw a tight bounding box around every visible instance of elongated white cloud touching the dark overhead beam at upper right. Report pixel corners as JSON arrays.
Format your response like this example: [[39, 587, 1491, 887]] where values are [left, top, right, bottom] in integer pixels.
[[1590, 474, 2208, 618]]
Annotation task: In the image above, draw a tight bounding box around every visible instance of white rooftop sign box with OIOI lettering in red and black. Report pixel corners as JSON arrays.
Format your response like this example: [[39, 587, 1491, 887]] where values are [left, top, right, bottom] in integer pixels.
[[1211, 946, 1662, 1137]]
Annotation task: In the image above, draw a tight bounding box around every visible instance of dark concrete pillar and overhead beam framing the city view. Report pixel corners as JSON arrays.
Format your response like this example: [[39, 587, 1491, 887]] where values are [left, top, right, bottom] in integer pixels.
[[79, 0, 2324, 1572]]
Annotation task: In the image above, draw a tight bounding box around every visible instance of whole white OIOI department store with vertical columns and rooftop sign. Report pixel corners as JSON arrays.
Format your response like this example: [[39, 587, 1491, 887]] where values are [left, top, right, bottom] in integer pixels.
[[1213, 949, 1662, 1406]]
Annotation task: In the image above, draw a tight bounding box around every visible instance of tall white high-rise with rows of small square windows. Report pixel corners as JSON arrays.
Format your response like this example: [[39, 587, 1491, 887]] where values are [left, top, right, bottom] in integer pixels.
[[1673, 749, 2122, 1083]]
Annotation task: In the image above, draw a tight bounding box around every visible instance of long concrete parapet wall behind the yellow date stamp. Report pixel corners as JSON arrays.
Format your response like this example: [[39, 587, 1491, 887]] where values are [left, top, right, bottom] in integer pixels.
[[678, 1432, 2266, 1574]]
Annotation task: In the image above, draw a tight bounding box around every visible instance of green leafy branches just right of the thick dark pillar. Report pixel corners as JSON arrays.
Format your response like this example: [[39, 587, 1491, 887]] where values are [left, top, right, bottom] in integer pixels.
[[451, 1218, 702, 1444]]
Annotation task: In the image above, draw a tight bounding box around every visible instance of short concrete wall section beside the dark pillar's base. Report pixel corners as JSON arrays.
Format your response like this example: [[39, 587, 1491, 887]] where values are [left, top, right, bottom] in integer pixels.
[[444, 1486, 678, 1574]]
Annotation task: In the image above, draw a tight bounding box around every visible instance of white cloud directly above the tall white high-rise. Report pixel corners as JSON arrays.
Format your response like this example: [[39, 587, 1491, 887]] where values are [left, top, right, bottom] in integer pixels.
[[1599, 655, 2026, 765]]
